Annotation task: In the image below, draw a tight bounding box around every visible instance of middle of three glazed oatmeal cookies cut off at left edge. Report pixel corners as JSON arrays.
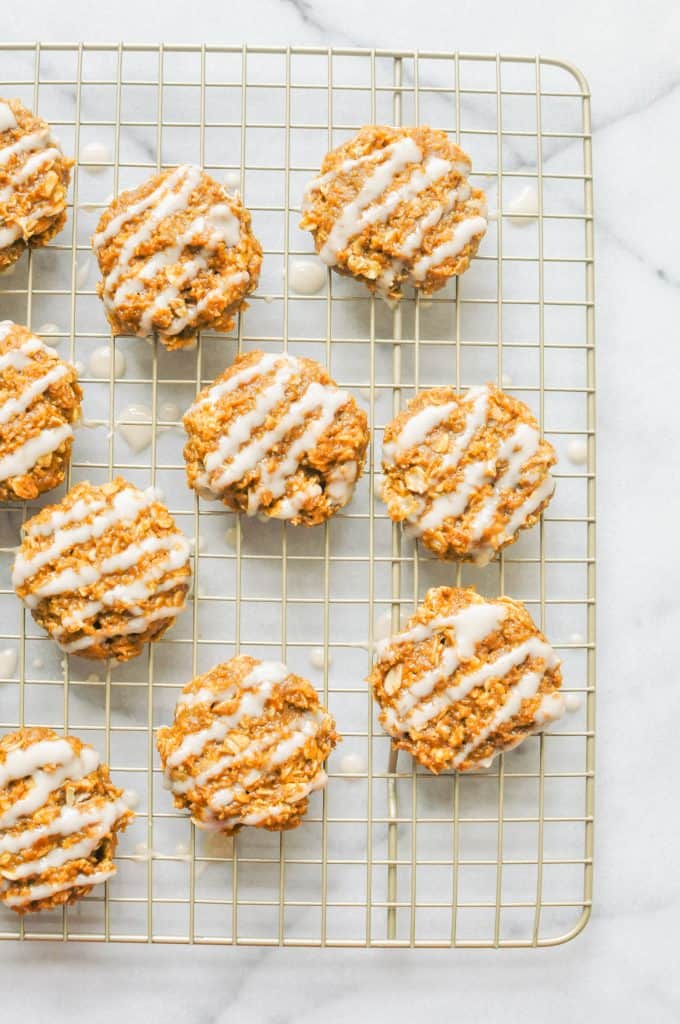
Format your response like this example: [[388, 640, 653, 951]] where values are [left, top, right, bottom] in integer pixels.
[[0, 321, 83, 502]]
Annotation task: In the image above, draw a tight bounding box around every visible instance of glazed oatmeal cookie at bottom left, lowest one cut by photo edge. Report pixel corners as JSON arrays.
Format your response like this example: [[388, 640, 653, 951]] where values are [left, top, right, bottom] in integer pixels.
[[0, 728, 133, 913]]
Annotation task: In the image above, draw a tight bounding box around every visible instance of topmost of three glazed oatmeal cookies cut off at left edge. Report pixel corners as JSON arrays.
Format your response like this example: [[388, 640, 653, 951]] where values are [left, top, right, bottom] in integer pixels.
[[0, 99, 74, 271]]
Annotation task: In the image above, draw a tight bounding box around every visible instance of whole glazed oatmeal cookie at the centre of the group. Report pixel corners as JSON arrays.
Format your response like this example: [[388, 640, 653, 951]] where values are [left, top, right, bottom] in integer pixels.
[[184, 351, 369, 526]]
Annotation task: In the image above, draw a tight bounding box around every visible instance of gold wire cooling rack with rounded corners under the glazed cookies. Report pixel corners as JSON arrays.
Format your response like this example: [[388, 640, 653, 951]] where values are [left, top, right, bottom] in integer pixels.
[[0, 44, 595, 947]]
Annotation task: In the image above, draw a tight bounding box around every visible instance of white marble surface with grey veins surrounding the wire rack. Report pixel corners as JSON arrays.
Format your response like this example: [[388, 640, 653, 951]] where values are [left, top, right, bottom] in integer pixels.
[[0, 0, 680, 1024]]
